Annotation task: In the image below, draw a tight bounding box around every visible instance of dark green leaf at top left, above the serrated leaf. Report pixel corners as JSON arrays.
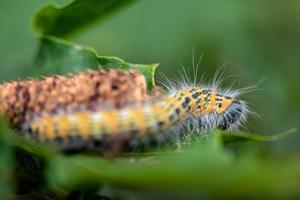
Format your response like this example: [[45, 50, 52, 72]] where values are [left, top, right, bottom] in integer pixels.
[[33, 0, 134, 37]]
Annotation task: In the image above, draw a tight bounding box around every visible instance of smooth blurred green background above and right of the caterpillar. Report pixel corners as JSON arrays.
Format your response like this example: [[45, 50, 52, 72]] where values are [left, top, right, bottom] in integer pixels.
[[0, 0, 300, 151]]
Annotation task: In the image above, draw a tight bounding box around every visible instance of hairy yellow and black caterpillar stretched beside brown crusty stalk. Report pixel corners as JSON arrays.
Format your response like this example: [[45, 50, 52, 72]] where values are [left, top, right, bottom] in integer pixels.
[[27, 68, 249, 151]]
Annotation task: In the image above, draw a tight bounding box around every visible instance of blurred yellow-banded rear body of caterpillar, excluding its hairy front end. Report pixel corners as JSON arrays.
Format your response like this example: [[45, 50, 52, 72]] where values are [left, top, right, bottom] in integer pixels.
[[29, 95, 186, 141]]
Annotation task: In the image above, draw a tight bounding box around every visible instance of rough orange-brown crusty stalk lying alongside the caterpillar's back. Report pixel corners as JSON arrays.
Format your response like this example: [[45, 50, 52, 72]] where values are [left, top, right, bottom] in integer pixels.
[[0, 69, 159, 128]]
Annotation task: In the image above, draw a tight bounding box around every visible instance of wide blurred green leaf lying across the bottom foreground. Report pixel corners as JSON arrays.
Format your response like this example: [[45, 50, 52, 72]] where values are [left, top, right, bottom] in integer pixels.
[[47, 145, 300, 199]]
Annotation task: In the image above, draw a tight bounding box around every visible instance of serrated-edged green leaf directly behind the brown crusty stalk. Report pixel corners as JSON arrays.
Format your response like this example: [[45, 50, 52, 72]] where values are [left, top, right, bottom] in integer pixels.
[[33, 36, 158, 90]]
